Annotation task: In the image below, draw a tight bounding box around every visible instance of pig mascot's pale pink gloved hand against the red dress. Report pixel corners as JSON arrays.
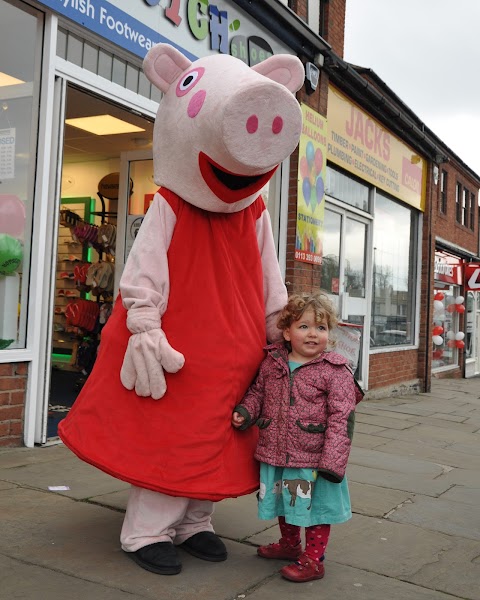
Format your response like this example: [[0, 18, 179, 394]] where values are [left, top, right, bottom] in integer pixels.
[[120, 309, 185, 400]]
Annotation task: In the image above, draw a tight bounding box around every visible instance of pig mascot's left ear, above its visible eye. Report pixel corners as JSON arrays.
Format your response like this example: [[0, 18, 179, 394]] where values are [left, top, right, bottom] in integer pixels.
[[143, 44, 192, 93]]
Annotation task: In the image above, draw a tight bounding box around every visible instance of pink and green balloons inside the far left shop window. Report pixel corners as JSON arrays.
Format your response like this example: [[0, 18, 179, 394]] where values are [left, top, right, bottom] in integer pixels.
[[0, 194, 25, 276]]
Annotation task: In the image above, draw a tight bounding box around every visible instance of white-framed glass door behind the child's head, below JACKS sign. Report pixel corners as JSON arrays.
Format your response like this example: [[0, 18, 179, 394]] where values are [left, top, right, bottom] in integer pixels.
[[321, 205, 369, 381]]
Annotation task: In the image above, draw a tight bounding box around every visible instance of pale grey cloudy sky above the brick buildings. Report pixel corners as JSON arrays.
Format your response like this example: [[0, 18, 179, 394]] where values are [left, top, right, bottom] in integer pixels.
[[345, 0, 480, 176]]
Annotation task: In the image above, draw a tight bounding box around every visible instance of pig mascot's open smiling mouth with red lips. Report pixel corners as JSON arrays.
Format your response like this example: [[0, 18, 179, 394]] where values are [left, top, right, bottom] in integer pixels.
[[198, 152, 278, 204]]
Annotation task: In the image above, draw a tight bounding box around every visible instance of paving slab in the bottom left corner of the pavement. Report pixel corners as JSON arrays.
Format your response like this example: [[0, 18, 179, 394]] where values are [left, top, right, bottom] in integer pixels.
[[0, 556, 144, 600]]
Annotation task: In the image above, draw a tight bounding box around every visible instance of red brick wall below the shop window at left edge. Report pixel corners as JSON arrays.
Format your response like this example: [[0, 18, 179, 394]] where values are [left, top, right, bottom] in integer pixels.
[[0, 363, 28, 447]]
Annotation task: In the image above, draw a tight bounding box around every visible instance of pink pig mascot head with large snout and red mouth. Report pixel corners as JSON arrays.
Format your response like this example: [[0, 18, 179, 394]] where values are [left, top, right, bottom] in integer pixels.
[[143, 44, 304, 213]]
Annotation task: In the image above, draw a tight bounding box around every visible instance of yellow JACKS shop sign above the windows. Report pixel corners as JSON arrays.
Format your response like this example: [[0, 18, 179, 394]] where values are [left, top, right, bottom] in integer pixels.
[[327, 85, 426, 211]]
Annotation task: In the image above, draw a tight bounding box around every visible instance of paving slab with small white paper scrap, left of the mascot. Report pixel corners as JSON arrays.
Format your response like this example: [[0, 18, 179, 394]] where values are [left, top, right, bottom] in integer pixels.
[[0, 455, 130, 499]]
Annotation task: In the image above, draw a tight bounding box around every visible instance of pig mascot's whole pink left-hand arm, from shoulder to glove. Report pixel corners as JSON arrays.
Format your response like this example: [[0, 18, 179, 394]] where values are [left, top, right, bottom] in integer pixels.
[[120, 194, 185, 399]]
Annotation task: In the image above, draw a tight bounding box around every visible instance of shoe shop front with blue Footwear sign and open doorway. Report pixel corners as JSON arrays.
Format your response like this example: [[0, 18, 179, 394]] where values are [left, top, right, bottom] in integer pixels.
[[0, 0, 304, 446]]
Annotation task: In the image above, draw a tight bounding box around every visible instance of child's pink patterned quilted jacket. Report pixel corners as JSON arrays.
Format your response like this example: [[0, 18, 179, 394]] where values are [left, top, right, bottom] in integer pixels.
[[235, 342, 363, 483]]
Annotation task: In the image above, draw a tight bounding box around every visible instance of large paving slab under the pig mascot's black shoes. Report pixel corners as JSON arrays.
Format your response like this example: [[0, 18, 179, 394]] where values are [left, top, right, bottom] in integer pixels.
[[0, 489, 284, 600]]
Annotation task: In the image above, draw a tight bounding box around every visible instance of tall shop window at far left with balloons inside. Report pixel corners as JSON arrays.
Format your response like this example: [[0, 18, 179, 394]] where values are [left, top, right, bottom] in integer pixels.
[[0, 0, 42, 350]]
